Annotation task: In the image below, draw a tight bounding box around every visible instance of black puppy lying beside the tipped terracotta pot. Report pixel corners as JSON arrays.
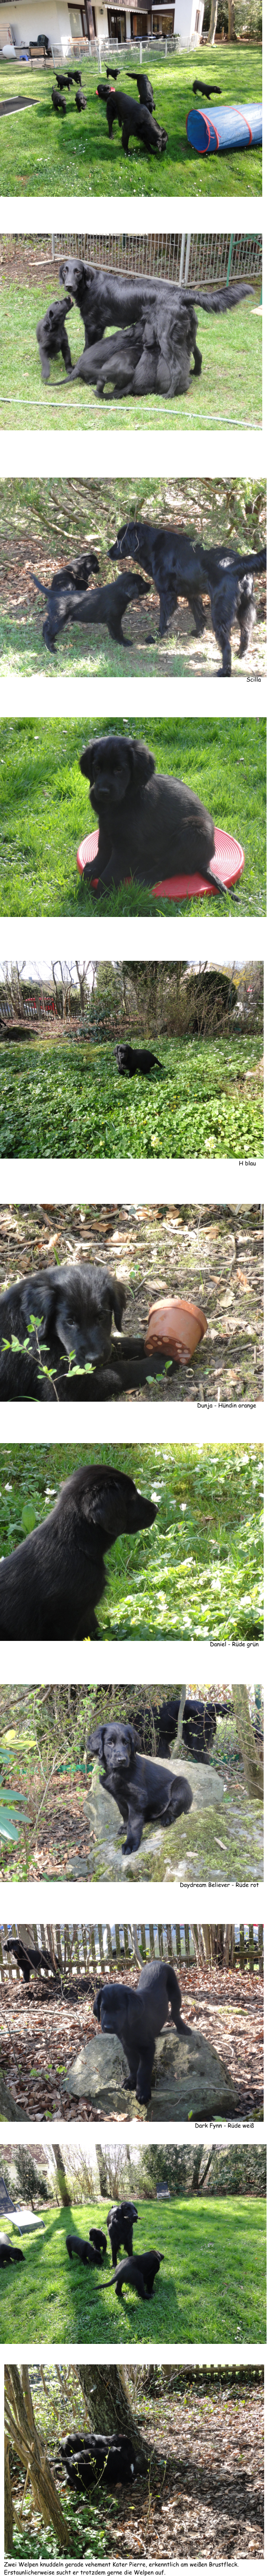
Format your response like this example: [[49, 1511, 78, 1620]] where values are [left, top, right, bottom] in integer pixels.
[[0, 1262, 173, 1404]]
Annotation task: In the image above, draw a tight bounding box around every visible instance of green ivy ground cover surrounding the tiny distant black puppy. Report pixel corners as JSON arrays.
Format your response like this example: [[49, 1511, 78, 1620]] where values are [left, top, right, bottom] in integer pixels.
[[0, 1036, 262, 1164]]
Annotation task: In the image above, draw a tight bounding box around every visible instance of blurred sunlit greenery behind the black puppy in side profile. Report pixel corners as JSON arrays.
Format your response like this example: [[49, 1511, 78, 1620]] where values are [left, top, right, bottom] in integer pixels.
[[0, 1417, 262, 1643]]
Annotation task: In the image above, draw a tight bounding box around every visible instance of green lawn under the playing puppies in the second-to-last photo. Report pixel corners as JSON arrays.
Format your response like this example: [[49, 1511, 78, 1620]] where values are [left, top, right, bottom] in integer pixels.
[[0, 2197, 267, 2352]]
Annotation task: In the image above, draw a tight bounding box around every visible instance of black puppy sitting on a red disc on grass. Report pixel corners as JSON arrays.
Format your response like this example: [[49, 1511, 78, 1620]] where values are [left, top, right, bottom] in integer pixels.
[[80, 734, 223, 899]]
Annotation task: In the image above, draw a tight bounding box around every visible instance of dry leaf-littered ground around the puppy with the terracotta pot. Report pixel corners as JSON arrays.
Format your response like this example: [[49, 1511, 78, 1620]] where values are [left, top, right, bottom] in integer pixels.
[[0, 1190, 265, 1409]]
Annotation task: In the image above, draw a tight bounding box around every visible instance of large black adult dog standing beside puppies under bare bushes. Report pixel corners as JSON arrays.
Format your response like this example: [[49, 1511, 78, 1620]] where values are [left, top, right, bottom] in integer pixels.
[[108, 520, 267, 680]]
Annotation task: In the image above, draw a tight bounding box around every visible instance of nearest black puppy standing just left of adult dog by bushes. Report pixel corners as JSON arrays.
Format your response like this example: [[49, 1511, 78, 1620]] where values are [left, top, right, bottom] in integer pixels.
[[44, 572, 146, 652]]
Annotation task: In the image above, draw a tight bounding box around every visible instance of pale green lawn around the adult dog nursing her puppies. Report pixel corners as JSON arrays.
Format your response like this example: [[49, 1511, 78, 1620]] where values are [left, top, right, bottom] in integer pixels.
[[0, 268, 262, 435]]
